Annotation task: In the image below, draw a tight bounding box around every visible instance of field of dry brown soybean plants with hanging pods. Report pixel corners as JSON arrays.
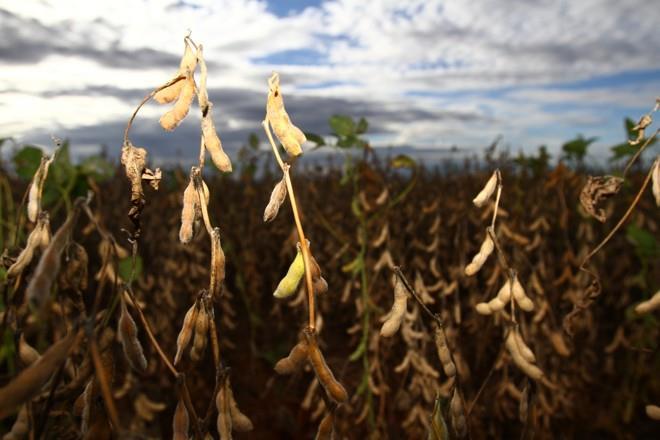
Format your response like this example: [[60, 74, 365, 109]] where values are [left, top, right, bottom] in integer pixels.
[[0, 35, 660, 440]]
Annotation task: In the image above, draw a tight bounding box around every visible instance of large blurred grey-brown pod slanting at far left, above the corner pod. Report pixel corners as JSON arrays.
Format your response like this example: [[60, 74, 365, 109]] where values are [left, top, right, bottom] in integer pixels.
[[26, 203, 81, 309]]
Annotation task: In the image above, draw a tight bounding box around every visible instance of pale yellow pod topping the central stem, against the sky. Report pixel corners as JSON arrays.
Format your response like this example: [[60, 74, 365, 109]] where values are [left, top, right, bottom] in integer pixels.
[[266, 73, 307, 157]]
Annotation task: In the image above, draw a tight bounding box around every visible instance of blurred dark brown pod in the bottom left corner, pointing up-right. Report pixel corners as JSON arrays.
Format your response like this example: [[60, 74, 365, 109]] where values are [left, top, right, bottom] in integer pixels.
[[0, 331, 79, 419]]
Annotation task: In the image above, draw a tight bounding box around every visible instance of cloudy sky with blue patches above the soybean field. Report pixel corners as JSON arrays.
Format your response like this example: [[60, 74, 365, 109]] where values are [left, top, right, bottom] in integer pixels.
[[0, 0, 660, 167]]
